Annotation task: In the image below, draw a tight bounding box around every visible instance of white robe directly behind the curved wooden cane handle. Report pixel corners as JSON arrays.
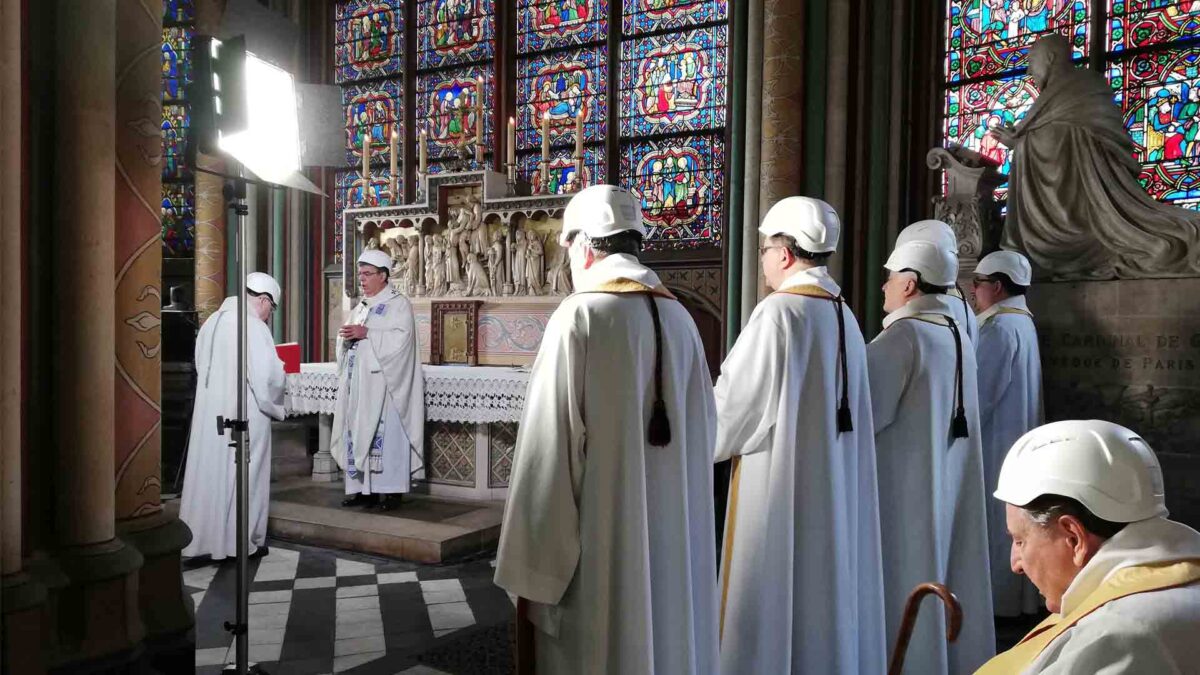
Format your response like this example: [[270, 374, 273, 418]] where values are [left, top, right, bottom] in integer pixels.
[[866, 294, 996, 675]]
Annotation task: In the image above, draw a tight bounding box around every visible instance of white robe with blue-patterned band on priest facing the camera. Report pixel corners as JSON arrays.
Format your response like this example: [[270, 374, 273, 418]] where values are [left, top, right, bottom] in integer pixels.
[[329, 286, 425, 495]]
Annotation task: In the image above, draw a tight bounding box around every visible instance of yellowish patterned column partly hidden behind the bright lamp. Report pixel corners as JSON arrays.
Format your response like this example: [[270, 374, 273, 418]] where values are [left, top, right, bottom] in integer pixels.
[[194, 0, 226, 322]]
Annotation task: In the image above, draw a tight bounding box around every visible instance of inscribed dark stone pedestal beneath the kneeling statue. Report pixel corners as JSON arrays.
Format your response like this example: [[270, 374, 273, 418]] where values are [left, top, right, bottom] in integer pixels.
[[1030, 279, 1200, 527]]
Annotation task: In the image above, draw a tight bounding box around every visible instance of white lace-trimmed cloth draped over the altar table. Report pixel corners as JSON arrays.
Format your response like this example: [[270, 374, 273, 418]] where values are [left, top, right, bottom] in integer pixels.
[[283, 363, 529, 423]]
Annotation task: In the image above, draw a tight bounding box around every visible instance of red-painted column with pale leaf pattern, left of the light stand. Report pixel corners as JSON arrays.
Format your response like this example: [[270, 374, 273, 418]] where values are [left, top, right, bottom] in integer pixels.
[[113, 0, 194, 671]]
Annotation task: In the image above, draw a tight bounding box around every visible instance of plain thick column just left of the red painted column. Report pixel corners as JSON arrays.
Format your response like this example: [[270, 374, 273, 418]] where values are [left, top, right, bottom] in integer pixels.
[[50, 0, 144, 668]]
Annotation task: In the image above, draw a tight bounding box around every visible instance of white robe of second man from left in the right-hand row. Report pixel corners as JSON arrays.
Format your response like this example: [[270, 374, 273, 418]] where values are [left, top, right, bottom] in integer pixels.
[[716, 267, 887, 675]]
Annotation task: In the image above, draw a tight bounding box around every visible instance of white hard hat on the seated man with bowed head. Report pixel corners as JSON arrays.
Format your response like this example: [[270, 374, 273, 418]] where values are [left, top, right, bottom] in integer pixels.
[[995, 419, 1166, 522]]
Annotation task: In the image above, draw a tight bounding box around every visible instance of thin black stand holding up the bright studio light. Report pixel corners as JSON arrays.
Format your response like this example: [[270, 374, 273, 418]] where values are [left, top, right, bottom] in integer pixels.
[[217, 162, 266, 675]]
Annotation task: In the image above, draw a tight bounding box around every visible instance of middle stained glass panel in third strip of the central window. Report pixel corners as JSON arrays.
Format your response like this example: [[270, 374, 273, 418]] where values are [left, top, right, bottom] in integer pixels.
[[517, 47, 608, 149]]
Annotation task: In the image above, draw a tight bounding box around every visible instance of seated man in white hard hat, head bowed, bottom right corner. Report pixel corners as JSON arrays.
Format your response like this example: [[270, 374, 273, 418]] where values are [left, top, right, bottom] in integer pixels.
[[979, 419, 1200, 675]]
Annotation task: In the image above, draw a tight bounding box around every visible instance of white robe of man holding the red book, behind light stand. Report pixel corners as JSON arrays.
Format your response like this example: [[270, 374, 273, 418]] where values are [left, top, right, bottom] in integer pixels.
[[179, 298, 284, 560]]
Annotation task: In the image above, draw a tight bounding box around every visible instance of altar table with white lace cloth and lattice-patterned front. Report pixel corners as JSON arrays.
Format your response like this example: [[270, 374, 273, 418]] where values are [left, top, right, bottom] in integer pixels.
[[284, 363, 529, 500]]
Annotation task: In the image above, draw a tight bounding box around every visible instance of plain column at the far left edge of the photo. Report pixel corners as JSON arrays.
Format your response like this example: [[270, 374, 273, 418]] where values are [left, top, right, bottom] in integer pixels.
[[0, 0, 46, 675]]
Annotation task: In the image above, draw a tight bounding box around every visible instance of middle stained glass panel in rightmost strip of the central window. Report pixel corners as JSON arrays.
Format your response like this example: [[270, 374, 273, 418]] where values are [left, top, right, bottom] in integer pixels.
[[620, 25, 728, 136]]
